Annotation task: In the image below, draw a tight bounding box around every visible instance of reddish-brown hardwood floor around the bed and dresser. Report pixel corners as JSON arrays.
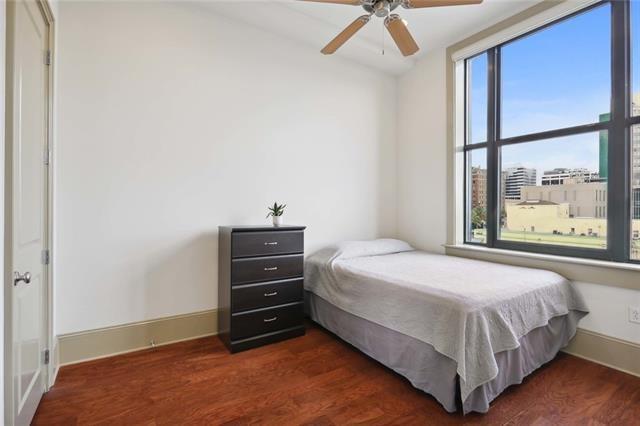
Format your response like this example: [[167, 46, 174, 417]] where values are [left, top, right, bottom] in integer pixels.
[[34, 325, 640, 425]]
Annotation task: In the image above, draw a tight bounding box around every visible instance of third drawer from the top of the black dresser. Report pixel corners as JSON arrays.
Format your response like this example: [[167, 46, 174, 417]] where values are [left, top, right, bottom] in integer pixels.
[[231, 279, 303, 312]]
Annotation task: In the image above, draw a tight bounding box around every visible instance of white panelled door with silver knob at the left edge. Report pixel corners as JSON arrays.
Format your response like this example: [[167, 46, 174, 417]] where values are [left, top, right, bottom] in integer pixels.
[[7, 0, 49, 425]]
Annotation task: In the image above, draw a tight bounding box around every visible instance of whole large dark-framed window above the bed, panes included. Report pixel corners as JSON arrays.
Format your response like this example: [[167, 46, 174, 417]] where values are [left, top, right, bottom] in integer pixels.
[[464, 0, 640, 262]]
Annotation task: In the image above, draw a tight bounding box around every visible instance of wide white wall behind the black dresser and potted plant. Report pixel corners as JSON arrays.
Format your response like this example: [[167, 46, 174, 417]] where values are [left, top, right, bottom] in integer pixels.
[[54, 2, 396, 334]]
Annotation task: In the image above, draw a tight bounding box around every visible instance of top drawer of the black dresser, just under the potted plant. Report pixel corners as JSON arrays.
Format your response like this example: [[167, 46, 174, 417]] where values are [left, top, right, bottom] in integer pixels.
[[231, 231, 304, 257]]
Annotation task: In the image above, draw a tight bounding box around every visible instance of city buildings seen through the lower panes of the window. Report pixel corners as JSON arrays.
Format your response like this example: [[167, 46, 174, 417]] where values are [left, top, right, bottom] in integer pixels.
[[470, 105, 640, 259]]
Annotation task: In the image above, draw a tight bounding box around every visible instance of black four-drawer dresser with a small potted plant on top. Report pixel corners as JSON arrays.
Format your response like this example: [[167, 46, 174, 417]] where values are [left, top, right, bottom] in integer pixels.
[[218, 226, 305, 353]]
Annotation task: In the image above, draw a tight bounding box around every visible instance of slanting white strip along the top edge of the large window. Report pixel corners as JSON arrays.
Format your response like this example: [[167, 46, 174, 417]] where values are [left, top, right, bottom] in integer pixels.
[[451, 0, 600, 62]]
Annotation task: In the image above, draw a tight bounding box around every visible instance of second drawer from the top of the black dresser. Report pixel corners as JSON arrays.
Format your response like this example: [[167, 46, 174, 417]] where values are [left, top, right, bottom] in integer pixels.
[[231, 254, 304, 285]]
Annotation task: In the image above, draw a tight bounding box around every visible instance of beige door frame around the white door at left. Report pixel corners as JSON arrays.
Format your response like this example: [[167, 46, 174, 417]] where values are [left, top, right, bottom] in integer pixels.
[[2, 0, 57, 425]]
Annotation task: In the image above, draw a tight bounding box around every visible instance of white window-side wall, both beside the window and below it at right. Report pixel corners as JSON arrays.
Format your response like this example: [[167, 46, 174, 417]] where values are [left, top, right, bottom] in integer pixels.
[[397, 50, 640, 343]]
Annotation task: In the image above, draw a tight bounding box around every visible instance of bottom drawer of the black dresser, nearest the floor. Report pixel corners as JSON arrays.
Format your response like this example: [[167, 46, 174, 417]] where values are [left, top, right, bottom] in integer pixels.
[[231, 303, 304, 340]]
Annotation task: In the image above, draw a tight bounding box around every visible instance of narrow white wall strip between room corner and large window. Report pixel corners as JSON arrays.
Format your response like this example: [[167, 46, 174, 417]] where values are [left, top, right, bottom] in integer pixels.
[[397, 49, 447, 252]]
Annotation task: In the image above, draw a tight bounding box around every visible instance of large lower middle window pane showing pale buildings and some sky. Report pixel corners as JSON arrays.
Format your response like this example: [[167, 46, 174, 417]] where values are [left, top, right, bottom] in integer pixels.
[[498, 133, 607, 249]]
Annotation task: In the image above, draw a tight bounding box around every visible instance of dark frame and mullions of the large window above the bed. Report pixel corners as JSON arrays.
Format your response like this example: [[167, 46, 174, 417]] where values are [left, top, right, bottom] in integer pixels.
[[461, 0, 640, 264]]
